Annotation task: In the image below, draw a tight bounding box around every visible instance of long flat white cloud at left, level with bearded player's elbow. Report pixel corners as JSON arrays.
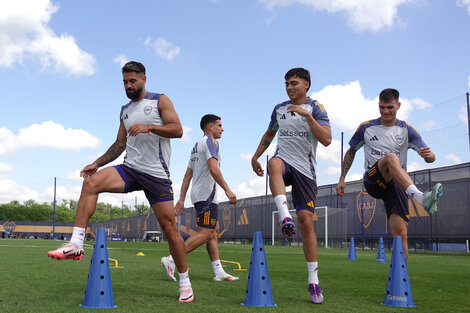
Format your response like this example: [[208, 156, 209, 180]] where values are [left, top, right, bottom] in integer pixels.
[[0, 121, 101, 155]]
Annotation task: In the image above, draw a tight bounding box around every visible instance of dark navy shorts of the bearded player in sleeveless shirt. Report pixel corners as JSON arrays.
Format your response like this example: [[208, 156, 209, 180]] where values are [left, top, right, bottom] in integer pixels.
[[114, 164, 173, 206]]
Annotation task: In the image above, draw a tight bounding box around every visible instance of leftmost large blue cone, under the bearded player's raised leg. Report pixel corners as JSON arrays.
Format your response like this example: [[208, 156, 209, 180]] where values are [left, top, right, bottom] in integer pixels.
[[80, 227, 117, 309]]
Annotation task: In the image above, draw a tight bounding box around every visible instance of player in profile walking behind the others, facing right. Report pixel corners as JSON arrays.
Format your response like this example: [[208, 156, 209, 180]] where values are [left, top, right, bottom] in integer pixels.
[[161, 114, 239, 281]]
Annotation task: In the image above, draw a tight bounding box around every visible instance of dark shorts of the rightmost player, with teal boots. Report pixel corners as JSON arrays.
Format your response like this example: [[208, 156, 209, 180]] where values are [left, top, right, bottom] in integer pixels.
[[364, 161, 410, 222]]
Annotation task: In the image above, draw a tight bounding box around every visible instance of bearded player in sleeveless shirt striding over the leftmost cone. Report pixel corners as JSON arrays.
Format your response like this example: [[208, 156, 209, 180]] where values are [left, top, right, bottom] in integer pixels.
[[47, 61, 194, 302]]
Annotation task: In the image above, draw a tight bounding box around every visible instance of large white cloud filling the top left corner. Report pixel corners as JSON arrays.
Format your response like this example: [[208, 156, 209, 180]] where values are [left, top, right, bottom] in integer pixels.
[[0, 0, 96, 76]]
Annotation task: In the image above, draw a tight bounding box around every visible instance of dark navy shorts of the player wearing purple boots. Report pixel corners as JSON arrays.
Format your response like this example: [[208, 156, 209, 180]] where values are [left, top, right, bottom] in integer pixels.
[[281, 159, 318, 212]]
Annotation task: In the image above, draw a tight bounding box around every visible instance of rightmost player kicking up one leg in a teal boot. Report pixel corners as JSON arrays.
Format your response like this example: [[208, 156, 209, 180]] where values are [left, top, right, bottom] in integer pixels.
[[336, 88, 443, 261]]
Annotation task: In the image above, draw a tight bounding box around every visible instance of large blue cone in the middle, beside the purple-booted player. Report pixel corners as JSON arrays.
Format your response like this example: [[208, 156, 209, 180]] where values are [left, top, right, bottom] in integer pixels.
[[242, 231, 277, 307]]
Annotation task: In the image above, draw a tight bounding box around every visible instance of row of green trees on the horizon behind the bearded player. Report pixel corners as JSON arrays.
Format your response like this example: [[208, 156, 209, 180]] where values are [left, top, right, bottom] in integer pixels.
[[0, 200, 150, 222]]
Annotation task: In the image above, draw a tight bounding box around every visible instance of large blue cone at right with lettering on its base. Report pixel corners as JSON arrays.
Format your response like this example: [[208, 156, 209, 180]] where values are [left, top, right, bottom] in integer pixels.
[[382, 236, 415, 308]]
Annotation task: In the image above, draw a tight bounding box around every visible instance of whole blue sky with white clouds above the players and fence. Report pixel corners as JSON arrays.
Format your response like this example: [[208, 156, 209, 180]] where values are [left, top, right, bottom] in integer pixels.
[[0, 0, 470, 205]]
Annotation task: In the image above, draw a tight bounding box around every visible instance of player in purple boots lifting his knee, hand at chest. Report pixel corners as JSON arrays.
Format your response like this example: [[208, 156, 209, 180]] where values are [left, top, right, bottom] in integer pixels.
[[251, 68, 331, 304]]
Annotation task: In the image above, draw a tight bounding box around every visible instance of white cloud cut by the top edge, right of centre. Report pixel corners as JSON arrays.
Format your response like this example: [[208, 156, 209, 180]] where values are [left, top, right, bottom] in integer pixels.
[[258, 0, 414, 32]]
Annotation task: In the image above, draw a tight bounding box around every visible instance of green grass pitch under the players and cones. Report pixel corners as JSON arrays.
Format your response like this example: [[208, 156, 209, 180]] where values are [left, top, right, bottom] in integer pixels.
[[0, 239, 470, 313]]
